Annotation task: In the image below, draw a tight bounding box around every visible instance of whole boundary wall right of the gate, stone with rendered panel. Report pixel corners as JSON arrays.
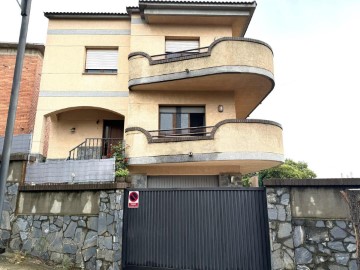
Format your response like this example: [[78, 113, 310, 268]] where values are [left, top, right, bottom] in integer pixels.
[[264, 179, 360, 270]]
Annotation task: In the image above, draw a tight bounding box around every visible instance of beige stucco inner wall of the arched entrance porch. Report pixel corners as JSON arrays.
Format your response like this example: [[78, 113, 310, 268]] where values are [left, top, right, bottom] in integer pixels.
[[47, 109, 123, 159]]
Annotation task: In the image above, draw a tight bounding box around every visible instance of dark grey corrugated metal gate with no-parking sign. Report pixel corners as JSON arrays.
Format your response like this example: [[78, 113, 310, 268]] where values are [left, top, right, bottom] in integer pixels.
[[123, 188, 271, 270]]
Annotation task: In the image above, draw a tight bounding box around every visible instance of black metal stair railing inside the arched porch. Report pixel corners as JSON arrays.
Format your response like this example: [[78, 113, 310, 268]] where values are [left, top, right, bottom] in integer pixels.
[[68, 138, 122, 160]]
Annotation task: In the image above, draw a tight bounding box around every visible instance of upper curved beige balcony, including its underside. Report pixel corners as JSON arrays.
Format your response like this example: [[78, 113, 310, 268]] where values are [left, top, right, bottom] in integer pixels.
[[129, 37, 275, 119]]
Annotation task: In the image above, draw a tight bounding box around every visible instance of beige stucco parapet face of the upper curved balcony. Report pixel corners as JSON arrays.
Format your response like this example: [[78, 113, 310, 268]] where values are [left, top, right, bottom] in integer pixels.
[[129, 40, 274, 80]]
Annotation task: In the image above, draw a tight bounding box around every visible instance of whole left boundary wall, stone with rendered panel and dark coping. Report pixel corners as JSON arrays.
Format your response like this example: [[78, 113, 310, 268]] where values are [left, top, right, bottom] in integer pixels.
[[0, 183, 124, 269]]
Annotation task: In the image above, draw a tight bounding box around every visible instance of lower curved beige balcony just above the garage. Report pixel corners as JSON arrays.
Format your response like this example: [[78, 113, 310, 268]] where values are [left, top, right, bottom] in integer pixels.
[[126, 119, 284, 175]]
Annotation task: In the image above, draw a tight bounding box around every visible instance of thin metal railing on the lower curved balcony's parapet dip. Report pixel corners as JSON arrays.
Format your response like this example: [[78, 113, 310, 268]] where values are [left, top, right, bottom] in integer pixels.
[[149, 126, 214, 139]]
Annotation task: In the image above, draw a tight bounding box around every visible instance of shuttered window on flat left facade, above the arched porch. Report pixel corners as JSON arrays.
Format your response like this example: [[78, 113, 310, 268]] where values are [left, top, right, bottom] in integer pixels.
[[85, 49, 118, 73]]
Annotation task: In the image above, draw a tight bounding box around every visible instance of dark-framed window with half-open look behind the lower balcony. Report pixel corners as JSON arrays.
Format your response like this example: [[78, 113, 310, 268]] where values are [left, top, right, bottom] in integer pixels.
[[159, 106, 206, 136]]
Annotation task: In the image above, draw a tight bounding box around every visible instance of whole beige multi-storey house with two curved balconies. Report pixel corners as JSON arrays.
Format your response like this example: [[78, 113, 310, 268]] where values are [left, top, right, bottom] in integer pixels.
[[32, 1, 284, 187]]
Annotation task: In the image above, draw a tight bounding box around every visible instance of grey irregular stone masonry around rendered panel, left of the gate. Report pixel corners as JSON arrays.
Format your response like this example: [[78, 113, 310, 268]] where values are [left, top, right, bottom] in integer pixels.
[[0, 184, 124, 269]]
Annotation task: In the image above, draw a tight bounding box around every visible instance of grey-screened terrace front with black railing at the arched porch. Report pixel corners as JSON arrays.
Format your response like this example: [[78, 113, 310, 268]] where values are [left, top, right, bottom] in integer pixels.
[[25, 138, 123, 185]]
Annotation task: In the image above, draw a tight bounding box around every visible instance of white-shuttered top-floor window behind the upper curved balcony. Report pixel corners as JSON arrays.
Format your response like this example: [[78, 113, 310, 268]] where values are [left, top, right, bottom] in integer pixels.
[[165, 39, 199, 58]]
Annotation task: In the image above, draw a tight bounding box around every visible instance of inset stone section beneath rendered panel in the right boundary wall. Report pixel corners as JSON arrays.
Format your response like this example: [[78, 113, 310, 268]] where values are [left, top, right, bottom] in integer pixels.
[[292, 219, 358, 270]]
